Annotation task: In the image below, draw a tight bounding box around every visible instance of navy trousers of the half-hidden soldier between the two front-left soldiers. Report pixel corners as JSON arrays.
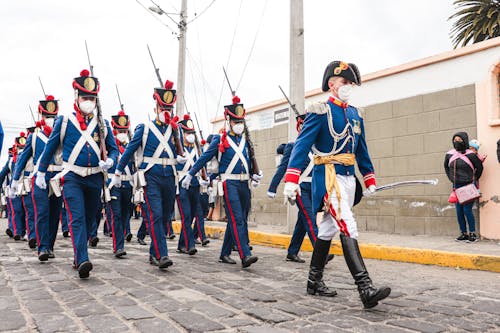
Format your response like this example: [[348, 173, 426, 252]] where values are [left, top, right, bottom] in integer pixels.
[[106, 182, 132, 252]]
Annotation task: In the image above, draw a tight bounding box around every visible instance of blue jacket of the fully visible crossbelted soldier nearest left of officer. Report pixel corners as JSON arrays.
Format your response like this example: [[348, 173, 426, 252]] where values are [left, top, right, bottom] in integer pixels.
[[189, 131, 250, 176]]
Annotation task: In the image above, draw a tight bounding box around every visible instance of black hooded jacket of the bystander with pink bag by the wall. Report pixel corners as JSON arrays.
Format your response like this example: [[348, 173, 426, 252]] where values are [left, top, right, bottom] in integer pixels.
[[444, 132, 483, 187]]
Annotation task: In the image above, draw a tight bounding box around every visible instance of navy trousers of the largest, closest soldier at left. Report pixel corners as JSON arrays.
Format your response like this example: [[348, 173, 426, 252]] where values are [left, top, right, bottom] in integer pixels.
[[63, 172, 103, 266]]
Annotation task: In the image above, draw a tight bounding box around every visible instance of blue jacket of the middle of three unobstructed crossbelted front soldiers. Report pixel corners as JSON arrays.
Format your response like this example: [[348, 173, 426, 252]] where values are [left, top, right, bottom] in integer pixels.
[[116, 120, 177, 176]]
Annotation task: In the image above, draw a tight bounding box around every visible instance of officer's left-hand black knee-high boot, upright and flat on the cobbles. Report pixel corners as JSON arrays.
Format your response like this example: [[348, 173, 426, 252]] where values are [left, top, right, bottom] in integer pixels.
[[307, 238, 337, 297]]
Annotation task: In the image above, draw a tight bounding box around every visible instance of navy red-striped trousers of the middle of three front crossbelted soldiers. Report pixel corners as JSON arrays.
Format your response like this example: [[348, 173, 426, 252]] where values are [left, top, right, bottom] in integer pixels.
[[144, 172, 175, 259]]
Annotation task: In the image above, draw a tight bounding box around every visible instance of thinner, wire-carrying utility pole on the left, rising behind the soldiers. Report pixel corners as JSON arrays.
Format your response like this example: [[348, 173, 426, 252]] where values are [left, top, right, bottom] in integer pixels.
[[175, 0, 187, 118]]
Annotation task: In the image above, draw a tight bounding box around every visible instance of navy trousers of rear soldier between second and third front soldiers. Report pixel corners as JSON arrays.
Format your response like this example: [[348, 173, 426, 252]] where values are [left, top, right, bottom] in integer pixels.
[[177, 186, 200, 250]]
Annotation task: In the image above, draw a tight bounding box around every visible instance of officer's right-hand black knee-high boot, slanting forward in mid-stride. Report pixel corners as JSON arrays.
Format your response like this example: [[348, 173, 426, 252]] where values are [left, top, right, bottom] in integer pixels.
[[340, 234, 391, 309]]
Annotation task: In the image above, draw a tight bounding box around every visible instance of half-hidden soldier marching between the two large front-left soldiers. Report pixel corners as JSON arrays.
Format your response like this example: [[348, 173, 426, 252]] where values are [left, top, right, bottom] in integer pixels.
[[106, 111, 135, 258]]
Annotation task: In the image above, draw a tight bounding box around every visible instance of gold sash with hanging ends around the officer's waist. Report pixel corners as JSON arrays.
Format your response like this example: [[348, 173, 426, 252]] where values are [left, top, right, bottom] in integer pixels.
[[314, 154, 356, 220]]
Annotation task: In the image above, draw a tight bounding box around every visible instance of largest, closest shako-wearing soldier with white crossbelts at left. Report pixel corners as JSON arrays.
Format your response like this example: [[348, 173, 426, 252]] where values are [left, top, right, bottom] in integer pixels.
[[35, 69, 118, 279]]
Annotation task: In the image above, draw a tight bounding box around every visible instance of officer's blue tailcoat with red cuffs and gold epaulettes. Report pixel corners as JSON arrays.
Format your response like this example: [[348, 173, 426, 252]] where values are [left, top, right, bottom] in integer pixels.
[[285, 101, 375, 211]]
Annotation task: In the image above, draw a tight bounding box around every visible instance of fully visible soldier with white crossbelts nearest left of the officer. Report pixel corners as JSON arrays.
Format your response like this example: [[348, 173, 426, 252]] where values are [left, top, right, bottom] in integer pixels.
[[182, 96, 262, 268]]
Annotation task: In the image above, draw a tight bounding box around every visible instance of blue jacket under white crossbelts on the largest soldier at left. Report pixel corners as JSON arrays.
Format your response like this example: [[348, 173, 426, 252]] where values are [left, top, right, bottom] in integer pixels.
[[38, 113, 118, 172]]
